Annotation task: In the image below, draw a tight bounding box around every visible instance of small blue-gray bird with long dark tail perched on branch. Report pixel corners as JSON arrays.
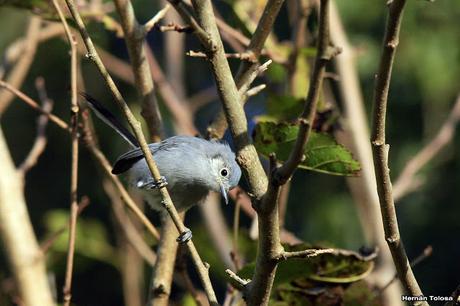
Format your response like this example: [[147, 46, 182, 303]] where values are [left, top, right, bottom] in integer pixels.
[[81, 93, 241, 215]]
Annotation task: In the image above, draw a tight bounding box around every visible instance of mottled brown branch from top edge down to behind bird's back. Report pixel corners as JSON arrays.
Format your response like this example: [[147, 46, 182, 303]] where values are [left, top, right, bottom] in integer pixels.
[[113, 0, 167, 142]]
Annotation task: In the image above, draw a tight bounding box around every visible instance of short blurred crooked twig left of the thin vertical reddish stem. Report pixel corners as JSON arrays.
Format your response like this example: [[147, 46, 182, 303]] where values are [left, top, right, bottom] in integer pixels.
[[18, 77, 54, 174]]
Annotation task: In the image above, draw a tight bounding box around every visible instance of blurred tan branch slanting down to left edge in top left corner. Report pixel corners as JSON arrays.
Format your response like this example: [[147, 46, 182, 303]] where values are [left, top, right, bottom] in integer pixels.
[[0, 15, 42, 115]]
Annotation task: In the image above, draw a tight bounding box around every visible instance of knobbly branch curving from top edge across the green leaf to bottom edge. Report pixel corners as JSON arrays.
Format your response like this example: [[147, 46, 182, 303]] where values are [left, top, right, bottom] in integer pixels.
[[245, 0, 337, 305]]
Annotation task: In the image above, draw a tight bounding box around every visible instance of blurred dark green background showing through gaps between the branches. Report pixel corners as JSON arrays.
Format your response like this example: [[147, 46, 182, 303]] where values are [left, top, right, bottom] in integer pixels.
[[0, 0, 460, 306]]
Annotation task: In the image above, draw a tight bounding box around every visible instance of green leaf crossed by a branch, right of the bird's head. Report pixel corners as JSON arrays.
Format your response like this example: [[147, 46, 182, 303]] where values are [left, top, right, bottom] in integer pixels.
[[253, 122, 360, 176]]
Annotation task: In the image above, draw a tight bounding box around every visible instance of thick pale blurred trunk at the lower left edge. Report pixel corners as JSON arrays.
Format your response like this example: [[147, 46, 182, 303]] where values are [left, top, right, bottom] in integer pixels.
[[0, 126, 55, 306]]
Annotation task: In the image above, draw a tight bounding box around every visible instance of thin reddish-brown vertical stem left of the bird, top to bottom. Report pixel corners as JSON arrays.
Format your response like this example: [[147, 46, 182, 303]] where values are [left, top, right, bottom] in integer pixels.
[[53, 0, 79, 306]]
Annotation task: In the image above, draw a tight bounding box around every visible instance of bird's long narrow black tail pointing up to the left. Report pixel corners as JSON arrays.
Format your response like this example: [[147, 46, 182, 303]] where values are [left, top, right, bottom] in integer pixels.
[[80, 92, 139, 148]]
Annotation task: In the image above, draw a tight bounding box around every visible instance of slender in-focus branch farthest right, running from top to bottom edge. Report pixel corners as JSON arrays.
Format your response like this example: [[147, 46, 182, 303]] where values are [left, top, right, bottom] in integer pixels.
[[371, 0, 428, 305]]
